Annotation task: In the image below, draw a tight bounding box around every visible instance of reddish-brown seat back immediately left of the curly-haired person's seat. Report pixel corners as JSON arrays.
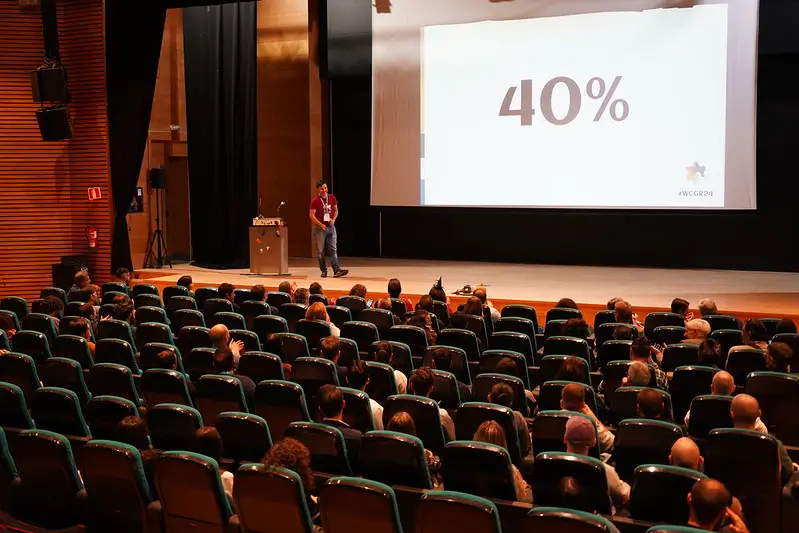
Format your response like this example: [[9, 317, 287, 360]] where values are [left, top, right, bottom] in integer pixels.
[[155, 451, 233, 533]]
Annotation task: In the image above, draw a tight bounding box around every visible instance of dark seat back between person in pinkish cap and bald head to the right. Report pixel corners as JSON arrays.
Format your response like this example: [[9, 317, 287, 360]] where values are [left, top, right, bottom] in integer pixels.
[[613, 419, 683, 483]]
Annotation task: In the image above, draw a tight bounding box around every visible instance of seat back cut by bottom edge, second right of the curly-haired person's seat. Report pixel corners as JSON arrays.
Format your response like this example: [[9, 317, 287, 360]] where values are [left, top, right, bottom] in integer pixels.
[[415, 490, 502, 533]]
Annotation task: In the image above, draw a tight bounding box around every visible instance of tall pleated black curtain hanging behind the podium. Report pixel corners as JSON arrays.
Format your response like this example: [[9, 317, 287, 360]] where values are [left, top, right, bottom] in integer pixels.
[[183, 1, 258, 268]]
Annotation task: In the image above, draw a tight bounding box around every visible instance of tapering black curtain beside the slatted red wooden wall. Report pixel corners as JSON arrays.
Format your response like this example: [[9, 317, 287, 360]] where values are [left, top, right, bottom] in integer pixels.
[[105, 0, 166, 271]]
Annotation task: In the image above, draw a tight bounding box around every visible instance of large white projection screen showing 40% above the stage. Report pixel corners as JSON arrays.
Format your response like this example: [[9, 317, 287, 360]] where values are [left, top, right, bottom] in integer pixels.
[[371, 0, 758, 210]]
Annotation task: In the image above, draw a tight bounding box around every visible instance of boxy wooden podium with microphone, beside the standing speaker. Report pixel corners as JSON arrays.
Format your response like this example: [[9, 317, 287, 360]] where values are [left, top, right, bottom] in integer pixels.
[[250, 218, 289, 276]]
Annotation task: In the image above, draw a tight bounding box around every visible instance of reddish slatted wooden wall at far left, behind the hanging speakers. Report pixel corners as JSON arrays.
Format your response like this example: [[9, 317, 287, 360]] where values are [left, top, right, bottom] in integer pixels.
[[0, 0, 113, 300]]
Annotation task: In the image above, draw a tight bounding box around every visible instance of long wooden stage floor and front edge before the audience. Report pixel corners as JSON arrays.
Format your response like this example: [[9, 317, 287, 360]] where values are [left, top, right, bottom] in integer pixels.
[[137, 258, 799, 321]]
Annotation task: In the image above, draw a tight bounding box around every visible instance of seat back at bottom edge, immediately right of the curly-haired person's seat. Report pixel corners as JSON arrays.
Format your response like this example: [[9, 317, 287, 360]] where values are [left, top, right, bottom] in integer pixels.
[[319, 477, 402, 533]]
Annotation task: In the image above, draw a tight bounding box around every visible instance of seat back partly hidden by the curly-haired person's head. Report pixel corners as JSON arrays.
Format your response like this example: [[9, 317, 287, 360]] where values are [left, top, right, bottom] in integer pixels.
[[285, 422, 352, 476]]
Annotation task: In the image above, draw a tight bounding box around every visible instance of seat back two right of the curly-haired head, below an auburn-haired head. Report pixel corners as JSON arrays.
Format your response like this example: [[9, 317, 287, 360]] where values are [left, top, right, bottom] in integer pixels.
[[361, 431, 433, 489]]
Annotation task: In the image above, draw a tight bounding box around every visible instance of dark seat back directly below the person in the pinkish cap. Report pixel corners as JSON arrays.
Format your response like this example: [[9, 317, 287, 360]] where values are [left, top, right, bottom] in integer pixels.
[[532, 452, 611, 515]]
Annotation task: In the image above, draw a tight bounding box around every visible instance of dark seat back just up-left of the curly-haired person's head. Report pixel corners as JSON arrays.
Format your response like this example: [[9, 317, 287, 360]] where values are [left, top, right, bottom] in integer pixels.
[[214, 411, 272, 465]]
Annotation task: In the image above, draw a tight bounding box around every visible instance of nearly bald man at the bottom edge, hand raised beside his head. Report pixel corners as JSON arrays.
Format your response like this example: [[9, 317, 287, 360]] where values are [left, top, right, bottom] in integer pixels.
[[688, 479, 749, 533]]
